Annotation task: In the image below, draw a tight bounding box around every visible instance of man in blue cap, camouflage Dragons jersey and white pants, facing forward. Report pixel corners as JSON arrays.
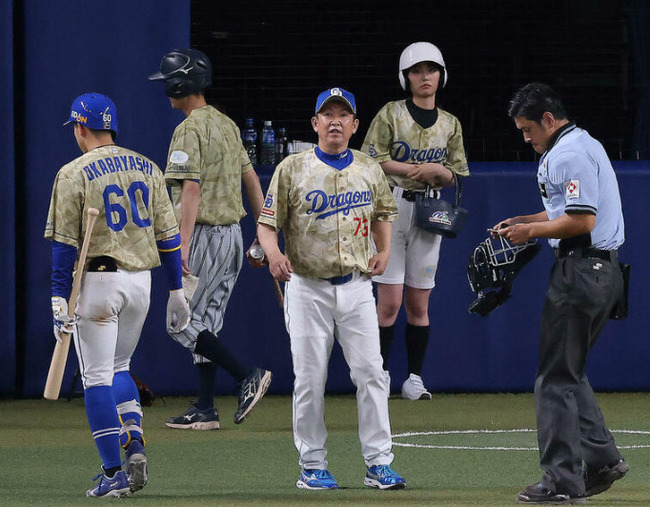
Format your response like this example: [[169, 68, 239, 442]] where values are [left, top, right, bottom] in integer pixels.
[[258, 88, 406, 490]]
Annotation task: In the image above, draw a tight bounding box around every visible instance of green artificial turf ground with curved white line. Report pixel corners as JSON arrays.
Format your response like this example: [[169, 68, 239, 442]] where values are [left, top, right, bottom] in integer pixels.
[[0, 393, 650, 507]]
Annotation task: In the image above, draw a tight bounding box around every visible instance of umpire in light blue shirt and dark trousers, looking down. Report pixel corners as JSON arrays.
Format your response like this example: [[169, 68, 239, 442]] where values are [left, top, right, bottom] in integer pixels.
[[495, 83, 629, 504]]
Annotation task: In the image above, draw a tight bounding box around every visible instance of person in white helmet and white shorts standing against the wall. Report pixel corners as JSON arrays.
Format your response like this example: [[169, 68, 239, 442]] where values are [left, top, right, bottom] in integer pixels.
[[361, 42, 469, 400]]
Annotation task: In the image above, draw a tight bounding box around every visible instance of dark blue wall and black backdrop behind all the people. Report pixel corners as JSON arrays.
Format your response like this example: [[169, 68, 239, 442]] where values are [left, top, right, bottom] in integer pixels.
[[0, 0, 650, 397]]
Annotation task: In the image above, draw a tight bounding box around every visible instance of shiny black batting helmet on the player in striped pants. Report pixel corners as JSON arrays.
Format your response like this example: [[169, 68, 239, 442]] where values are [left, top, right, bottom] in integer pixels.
[[149, 49, 212, 99]]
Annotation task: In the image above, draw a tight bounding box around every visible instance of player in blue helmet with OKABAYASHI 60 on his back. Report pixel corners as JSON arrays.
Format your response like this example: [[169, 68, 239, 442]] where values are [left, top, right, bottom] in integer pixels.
[[45, 93, 190, 497]]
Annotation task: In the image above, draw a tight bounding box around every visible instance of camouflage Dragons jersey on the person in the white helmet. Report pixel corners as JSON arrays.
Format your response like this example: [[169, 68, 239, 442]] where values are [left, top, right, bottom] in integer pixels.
[[361, 100, 469, 190]]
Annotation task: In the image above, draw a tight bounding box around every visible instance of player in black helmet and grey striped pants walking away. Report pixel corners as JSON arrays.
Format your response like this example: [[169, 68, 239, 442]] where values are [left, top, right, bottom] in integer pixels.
[[149, 49, 271, 430]]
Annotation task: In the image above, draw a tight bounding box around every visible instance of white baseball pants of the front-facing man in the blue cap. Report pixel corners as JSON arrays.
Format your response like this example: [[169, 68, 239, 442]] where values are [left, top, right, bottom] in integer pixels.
[[284, 273, 393, 469]]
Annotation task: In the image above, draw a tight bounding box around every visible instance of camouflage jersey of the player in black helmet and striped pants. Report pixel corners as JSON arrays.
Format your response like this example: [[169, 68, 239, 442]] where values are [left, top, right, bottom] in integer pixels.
[[165, 106, 253, 225]]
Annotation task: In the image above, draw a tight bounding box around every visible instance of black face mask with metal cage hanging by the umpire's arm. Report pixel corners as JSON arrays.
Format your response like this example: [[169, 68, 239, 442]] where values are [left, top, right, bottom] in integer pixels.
[[467, 236, 541, 316]]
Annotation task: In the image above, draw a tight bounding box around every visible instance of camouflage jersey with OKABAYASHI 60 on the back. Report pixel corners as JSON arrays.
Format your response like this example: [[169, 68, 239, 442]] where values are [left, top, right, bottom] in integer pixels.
[[45, 145, 179, 271]]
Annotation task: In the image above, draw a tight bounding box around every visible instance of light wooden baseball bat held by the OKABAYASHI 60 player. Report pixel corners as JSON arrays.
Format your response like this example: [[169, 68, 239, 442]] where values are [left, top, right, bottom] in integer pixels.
[[43, 208, 99, 400]]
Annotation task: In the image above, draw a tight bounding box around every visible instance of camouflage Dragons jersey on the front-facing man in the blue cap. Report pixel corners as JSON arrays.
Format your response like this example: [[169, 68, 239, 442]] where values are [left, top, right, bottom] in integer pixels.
[[258, 149, 397, 278]]
